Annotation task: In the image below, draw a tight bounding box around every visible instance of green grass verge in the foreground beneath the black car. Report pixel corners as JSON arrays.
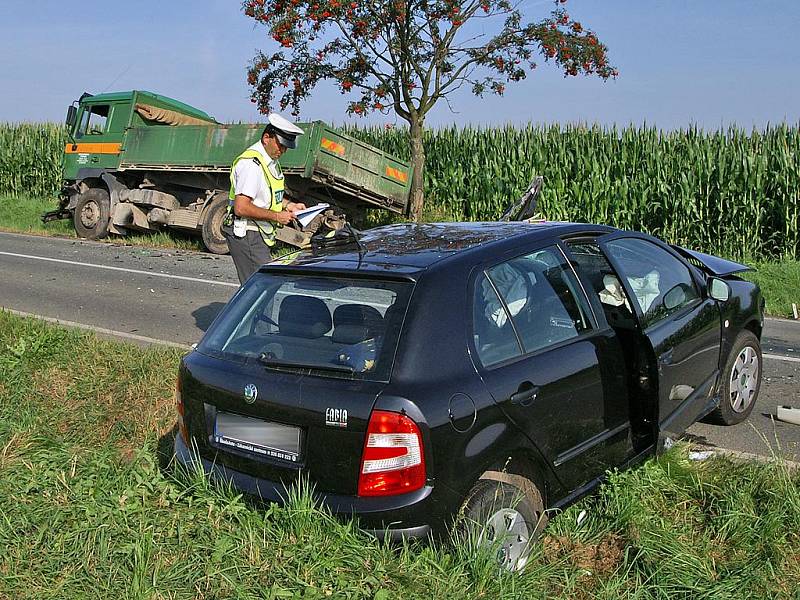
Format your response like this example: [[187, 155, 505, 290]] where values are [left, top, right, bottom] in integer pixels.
[[0, 312, 800, 600]]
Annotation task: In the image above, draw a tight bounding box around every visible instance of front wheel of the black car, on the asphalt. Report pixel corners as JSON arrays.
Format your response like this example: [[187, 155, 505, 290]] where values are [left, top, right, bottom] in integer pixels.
[[707, 331, 762, 425]]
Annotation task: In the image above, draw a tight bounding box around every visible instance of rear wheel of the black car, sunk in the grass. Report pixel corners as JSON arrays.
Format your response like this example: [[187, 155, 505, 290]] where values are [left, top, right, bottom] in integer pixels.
[[459, 475, 546, 571]]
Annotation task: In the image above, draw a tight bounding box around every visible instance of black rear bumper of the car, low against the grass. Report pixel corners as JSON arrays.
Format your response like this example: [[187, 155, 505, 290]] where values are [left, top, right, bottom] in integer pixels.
[[175, 435, 445, 540]]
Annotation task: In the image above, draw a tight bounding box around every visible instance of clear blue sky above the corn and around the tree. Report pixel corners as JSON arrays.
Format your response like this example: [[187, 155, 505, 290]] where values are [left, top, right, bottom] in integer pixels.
[[0, 0, 800, 129]]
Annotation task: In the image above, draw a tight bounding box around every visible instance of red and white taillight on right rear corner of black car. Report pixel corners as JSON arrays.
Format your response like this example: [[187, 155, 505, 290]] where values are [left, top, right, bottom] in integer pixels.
[[358, 410, 425, 496]]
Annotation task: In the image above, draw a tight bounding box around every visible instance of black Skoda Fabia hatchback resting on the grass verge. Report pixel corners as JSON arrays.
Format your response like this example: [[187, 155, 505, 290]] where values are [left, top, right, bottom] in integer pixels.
[[175, 222, 764, 569]]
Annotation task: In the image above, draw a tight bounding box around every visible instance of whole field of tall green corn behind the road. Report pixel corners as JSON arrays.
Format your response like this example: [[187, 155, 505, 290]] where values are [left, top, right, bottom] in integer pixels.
[[0, 124, 800, 259]]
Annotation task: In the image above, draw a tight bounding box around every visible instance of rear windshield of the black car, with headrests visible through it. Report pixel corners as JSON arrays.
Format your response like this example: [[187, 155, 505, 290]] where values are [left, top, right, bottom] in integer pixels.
[[197, 273, 413, 381]]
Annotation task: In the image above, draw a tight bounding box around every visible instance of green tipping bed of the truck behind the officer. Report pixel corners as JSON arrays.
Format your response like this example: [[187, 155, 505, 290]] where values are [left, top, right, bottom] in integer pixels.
[[124, 121, 411, 213]]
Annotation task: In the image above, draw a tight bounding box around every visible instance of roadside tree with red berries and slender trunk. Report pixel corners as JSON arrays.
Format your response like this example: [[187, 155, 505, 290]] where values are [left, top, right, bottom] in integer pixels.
[[243, 0, 617, 219]]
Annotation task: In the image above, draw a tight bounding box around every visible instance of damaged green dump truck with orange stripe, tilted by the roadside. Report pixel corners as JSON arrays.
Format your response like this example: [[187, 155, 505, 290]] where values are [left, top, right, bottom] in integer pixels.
[[42, 91, 411, 254]]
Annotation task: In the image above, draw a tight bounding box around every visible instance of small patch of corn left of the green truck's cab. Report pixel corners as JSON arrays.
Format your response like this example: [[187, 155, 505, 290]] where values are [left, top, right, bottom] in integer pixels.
[[0, 123, 66, 197]]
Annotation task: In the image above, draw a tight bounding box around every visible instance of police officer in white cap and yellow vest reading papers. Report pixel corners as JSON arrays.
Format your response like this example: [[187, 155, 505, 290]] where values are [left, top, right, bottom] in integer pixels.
[[222, 113, 306, 283]]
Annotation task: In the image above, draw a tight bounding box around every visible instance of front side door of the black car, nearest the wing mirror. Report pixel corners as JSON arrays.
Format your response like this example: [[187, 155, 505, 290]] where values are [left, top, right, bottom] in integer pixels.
[[598, 233, 721, 438]]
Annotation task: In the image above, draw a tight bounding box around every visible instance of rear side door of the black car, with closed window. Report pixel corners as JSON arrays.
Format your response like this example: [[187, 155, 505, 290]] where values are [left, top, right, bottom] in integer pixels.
[[471, 243, 632, 490]]
